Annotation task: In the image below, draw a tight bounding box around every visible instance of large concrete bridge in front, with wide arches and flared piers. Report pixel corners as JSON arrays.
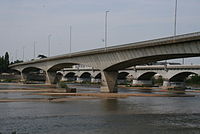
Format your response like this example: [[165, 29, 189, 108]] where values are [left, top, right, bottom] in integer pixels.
[[10, 32, 200, 92]]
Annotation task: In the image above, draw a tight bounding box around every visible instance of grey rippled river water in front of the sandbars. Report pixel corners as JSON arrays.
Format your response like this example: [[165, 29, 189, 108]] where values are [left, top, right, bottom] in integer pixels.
[[0, 85, 200, 134]]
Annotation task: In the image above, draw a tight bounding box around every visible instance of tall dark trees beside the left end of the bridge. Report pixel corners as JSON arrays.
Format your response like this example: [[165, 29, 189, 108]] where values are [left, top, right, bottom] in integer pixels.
[[0, 52, 10, 73]]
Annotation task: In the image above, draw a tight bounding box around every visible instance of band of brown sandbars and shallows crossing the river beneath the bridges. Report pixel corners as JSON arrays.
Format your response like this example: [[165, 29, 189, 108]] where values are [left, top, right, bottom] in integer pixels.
[[0, 83, 200, 103]]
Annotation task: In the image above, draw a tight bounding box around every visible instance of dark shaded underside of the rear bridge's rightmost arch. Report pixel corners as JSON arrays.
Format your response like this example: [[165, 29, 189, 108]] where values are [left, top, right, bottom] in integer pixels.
[[169, 72, 198, 82]]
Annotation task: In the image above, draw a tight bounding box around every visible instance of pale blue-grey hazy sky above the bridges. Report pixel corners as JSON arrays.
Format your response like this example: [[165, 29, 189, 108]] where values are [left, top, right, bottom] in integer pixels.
[[0, 0, 200, 64]]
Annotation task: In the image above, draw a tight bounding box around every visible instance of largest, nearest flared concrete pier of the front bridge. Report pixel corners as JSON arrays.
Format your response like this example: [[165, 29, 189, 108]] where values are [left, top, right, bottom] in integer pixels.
[[101, 71, 118, 93]]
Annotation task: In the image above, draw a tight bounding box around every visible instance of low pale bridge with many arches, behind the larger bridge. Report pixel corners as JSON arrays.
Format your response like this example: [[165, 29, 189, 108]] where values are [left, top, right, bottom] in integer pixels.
[[58, 65, 200, 87]]
